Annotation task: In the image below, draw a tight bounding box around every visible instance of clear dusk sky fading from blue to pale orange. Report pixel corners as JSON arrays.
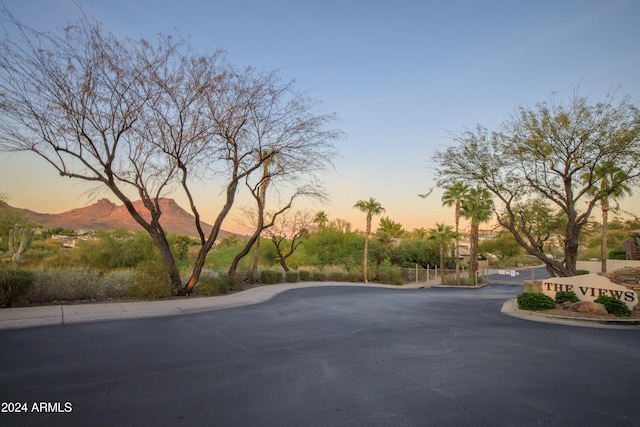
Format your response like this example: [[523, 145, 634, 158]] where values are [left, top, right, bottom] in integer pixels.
[[0, 0, 640, 231]]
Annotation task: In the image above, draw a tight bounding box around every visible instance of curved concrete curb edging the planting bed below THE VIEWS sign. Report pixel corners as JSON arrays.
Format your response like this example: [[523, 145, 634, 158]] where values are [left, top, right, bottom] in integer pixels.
[[500, 298, 640, 330]]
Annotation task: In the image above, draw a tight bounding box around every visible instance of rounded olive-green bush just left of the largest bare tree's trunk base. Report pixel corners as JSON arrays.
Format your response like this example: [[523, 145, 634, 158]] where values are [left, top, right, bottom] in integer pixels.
[[127, 261, 174, 300]]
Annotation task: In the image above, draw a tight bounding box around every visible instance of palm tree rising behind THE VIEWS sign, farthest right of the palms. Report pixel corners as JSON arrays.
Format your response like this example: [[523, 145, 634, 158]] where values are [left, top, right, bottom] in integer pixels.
[[583, 162, 631, 273]]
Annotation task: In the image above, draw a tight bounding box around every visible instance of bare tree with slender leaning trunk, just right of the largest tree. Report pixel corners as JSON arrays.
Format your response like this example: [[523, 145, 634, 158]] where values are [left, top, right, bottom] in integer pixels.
[[220, 73, 342, 282]]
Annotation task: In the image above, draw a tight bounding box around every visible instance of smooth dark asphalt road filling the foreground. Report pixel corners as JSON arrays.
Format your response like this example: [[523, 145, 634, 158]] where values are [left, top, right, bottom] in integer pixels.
[[0, 285, 640, 427]]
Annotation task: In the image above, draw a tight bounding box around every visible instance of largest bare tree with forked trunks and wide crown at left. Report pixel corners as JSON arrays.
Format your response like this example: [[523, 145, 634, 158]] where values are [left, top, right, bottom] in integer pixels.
[[0, 10, 340, 294]]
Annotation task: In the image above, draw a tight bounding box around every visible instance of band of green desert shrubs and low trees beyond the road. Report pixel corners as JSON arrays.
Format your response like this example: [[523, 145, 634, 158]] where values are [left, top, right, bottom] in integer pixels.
[[0, 186, 640, 307]]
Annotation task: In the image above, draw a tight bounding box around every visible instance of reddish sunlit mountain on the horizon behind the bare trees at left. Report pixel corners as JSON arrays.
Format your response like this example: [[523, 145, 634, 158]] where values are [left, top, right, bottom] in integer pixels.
[[20, 198, 233, 238]]
